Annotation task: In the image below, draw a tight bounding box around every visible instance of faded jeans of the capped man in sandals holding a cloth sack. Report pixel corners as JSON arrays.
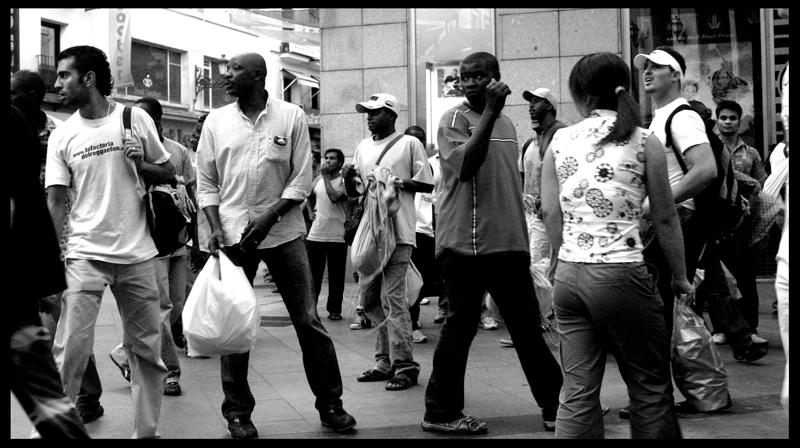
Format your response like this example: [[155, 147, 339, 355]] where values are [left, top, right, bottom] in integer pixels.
[[358, 244, 419, 380]]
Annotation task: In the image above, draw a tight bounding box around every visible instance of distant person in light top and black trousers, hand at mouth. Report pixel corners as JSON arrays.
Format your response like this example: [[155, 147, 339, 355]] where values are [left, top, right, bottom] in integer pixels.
[[306, 148, 347, 320]]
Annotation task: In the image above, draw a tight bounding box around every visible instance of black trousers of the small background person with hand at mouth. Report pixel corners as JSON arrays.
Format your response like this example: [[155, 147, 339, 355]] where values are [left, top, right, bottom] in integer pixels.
[[306, 240, 347, 314]]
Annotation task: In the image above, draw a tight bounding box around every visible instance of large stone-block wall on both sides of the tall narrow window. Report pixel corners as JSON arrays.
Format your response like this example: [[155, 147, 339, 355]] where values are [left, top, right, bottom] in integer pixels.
[[320, 8, 622, 157]]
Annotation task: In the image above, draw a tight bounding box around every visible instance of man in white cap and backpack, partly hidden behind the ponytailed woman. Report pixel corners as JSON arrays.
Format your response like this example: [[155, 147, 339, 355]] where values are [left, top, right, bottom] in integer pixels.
[[620, 47, 717, 418]]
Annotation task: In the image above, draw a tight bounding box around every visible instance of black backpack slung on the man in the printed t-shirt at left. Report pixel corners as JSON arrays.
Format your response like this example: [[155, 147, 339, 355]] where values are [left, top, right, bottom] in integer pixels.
[[122, 106, 190, 257]]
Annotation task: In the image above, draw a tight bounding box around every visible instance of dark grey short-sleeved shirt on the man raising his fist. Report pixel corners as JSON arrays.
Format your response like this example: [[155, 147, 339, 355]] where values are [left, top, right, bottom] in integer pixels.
[[436, 101, 529, 256]]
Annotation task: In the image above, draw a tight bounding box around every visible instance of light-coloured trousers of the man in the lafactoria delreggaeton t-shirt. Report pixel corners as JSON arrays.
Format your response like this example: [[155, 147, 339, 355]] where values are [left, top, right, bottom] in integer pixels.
[[53, 259, 167, 438]]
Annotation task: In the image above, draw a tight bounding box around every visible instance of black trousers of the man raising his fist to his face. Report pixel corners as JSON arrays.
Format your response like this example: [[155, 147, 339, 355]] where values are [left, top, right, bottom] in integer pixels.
[[425, 250, 562, 422]]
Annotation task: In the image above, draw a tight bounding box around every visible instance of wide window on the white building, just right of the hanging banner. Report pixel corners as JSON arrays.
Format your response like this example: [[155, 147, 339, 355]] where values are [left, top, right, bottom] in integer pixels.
[[117, 42, 182, 103]]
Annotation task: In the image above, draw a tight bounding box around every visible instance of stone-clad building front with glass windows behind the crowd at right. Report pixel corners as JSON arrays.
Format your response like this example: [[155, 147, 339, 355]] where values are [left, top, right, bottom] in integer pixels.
[[320, 8, 789, 274]]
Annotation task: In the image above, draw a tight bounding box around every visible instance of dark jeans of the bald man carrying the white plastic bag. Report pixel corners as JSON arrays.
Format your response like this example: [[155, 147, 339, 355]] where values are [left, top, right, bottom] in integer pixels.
[[220, 238, 342, 421]]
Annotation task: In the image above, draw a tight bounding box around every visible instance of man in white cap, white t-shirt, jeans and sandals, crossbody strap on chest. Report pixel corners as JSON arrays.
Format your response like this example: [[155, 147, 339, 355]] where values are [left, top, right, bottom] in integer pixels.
[[342, 93, 433, 390]]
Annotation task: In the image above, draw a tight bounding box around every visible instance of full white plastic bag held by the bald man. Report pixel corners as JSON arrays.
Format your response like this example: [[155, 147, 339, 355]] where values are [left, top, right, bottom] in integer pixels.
[[182, 251, 261, 356]]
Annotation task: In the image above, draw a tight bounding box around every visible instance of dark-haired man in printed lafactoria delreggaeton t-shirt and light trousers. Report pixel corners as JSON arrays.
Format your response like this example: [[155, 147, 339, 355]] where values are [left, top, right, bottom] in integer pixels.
[[45, 46, 175, 438]]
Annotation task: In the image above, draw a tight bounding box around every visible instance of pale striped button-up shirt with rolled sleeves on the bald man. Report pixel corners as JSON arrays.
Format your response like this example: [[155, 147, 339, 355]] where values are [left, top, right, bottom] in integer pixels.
[[197, 98, 311, 249]]
